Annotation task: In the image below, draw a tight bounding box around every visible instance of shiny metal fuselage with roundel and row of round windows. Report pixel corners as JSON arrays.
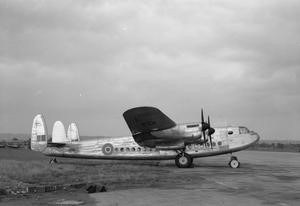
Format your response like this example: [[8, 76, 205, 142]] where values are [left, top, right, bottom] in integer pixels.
[[42, 124, 259, 160]]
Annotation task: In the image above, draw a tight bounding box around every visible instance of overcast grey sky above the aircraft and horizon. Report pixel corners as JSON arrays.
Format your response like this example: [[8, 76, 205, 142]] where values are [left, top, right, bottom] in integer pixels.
[[0, 0, 300, 140]]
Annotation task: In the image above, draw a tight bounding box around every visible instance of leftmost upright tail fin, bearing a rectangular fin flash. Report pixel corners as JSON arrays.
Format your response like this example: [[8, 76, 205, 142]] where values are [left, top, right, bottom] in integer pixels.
[[30, 114, 48, 152]]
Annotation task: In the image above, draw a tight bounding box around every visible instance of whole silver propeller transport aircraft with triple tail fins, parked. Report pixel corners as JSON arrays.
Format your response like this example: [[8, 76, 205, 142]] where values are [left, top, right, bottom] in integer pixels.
[[31, 107, 259, 168]]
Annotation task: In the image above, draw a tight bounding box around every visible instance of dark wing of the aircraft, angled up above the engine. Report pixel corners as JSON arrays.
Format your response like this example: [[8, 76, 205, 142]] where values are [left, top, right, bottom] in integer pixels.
[[123, 107, 176, 136]]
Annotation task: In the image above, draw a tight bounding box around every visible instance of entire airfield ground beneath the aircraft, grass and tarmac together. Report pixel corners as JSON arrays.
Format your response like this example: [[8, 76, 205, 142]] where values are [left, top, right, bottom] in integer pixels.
[[0, 149, 300, 205]]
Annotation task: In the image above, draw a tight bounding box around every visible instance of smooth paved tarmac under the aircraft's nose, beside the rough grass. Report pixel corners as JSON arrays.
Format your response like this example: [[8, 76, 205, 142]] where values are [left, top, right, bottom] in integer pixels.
[[0, 151, 300, 206]]
